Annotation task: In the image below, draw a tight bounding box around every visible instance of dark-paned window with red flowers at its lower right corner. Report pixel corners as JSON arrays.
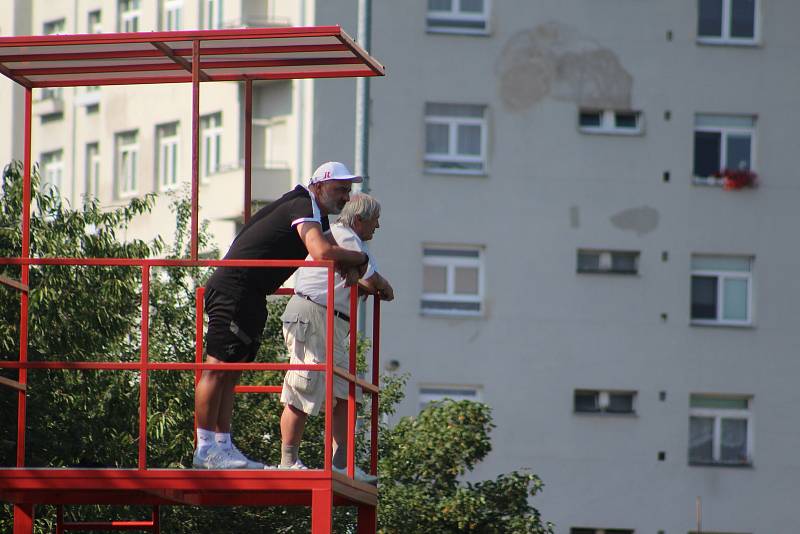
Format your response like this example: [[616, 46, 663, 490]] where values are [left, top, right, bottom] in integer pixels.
[[694, 114, 755, 183]]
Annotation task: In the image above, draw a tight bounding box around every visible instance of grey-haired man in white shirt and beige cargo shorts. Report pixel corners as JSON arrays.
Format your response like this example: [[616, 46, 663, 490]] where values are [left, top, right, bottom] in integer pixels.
[[280, 193, 394, 484]]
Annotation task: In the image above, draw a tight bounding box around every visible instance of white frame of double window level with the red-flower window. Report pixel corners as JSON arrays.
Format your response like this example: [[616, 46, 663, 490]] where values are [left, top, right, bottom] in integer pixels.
[[423, 104, 489, 176]]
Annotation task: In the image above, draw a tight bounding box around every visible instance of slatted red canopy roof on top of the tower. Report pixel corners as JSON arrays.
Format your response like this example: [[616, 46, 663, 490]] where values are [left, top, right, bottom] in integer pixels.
[[0, 26, 384, 87]]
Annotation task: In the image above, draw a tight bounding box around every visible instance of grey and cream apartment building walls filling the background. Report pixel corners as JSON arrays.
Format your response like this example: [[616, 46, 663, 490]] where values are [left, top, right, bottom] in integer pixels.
[[1, 0, 800, 534]]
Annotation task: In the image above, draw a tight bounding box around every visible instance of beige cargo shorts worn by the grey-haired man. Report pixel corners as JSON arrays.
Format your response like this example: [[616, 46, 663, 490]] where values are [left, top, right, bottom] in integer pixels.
[[281, 295, 361, 415]]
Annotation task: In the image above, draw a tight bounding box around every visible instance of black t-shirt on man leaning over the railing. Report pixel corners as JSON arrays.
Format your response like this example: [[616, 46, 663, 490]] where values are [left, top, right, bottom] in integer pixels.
[[206, 185, 329, 297]]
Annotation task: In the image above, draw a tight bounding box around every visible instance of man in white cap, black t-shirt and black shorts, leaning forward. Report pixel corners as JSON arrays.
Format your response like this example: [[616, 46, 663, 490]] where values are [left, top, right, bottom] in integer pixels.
[[192, 162, 369, 469]]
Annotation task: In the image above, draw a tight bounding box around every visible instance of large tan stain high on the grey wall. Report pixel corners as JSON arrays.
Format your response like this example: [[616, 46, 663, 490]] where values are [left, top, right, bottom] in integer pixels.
[[496, 22, 633, 111]]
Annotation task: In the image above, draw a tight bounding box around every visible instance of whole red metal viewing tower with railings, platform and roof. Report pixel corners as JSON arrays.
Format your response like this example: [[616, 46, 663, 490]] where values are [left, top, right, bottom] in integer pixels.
[[0, 26, 384, 534]]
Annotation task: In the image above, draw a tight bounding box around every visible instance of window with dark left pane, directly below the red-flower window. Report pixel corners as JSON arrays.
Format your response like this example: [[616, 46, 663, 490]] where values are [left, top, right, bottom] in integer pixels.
[[691, 255, 753, 326]]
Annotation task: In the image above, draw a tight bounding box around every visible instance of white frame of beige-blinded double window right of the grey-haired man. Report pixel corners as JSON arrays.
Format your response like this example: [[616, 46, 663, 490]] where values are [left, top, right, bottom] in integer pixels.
[[420, 244, 485, 317]]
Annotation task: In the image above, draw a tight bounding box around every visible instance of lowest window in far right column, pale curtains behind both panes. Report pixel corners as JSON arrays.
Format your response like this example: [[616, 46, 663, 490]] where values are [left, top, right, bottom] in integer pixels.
[[689, 395, 753, 465]]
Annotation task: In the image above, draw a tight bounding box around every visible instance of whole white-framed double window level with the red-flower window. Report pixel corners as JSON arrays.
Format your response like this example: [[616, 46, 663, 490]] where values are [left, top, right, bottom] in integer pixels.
[[425, 103, 487, 174]]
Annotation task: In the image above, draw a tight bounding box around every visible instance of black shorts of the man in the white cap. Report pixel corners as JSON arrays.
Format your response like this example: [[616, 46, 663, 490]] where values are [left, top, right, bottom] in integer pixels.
[[205, 288, 267, 363]]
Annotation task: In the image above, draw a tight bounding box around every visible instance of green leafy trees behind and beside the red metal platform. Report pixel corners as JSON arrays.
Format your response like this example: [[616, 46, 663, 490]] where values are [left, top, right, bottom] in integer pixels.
[[0, 163, 551, 534]]
